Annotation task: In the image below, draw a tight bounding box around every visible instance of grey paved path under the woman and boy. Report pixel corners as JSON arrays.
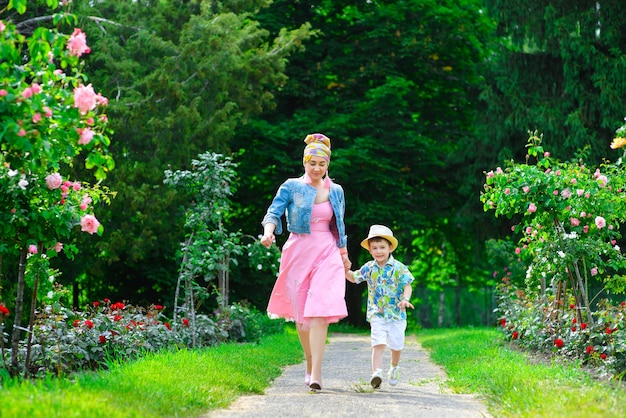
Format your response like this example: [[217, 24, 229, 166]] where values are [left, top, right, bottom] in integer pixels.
[[200, 334, 491, 418]]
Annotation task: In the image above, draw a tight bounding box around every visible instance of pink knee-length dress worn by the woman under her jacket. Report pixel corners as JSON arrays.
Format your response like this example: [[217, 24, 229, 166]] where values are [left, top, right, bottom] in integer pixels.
[[267, 202, 348, 329]]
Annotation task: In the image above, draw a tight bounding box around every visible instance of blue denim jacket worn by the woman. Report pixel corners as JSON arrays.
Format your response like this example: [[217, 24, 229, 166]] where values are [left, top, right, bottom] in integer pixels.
[[261, 177, 347, 248]]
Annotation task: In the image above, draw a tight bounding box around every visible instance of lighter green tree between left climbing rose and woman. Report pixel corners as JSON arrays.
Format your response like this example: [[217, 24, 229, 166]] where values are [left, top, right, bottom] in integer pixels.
[[61, 0, 310, 303]]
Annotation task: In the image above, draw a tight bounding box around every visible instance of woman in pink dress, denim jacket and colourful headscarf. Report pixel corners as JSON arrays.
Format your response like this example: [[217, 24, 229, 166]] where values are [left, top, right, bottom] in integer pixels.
[[261, 133, 352, 391]]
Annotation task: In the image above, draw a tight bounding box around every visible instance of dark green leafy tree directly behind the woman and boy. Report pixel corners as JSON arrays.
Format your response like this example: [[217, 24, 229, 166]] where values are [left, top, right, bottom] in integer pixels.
[[233, 0, 492, 320]]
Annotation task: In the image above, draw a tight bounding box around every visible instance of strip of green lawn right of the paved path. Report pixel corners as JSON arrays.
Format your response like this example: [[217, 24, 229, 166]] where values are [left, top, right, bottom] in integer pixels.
[[417, 328, 626, 418]]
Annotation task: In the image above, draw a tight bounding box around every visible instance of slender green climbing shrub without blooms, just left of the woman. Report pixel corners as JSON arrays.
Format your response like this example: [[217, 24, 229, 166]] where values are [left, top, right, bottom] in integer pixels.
[[164, 153, 279, 315]]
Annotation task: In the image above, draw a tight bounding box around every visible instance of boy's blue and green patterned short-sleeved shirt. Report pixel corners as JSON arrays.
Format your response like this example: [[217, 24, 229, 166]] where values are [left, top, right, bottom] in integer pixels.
[[354, 255, 415, 322]]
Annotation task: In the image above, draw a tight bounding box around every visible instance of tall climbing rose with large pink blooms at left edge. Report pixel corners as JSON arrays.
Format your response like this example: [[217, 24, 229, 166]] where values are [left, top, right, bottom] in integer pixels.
[[0, 0, 114, 376]]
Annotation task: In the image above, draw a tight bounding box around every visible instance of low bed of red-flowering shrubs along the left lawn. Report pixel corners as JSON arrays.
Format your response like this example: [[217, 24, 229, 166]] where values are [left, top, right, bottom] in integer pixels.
[[0, 299, 284, 377]]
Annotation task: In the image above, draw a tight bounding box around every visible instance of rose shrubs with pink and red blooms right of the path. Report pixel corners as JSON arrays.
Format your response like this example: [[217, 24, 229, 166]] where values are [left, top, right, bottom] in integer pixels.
[[481, 125, 626, 374]]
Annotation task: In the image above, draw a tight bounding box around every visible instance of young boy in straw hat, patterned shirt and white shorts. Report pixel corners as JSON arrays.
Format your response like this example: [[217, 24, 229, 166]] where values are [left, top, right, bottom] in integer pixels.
[[346, 225, 414, 389]]
